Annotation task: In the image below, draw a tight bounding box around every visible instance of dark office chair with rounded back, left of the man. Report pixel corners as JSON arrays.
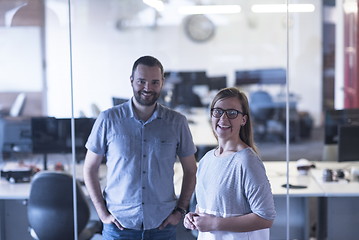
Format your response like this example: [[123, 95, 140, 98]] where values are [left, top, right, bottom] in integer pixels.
[[27, 171, 102, 240]]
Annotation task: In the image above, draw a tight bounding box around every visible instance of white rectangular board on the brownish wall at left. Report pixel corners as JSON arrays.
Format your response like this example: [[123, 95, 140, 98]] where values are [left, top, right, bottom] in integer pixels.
[[0, 27, 42, 92]]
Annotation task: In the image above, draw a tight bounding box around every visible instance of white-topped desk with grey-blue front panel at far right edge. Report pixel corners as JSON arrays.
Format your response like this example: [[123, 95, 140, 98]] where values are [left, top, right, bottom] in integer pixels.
[[311, 162, 359, 240]]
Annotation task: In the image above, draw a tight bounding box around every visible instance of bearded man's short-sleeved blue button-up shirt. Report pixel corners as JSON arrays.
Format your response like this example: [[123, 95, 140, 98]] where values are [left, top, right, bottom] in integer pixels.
[[86, 100, 196, 230]]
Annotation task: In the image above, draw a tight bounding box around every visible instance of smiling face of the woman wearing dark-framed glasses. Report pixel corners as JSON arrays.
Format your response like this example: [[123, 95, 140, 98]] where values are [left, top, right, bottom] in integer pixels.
[[211, 97, 247, 140]]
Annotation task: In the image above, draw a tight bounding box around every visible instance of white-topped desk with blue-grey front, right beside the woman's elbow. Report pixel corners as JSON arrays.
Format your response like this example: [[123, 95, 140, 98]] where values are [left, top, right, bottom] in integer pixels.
[[263, 161, 324, 239]]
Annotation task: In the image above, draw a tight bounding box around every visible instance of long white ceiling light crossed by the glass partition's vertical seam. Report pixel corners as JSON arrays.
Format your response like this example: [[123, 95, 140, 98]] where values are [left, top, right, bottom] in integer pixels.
[[251, 4, 315, 13]]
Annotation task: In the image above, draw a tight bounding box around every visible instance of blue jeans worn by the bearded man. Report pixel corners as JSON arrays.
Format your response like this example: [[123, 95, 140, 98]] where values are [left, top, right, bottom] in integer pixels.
[[102, 224, 176, 240]]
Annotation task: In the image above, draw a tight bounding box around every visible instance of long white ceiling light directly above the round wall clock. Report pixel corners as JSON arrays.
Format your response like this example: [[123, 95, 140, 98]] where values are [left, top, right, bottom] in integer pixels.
[[178, 5, 241, 15]]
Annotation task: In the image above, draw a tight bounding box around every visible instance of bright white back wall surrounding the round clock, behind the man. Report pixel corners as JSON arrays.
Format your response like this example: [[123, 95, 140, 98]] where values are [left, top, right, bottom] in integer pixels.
[[0, 0, 322, 125]]
